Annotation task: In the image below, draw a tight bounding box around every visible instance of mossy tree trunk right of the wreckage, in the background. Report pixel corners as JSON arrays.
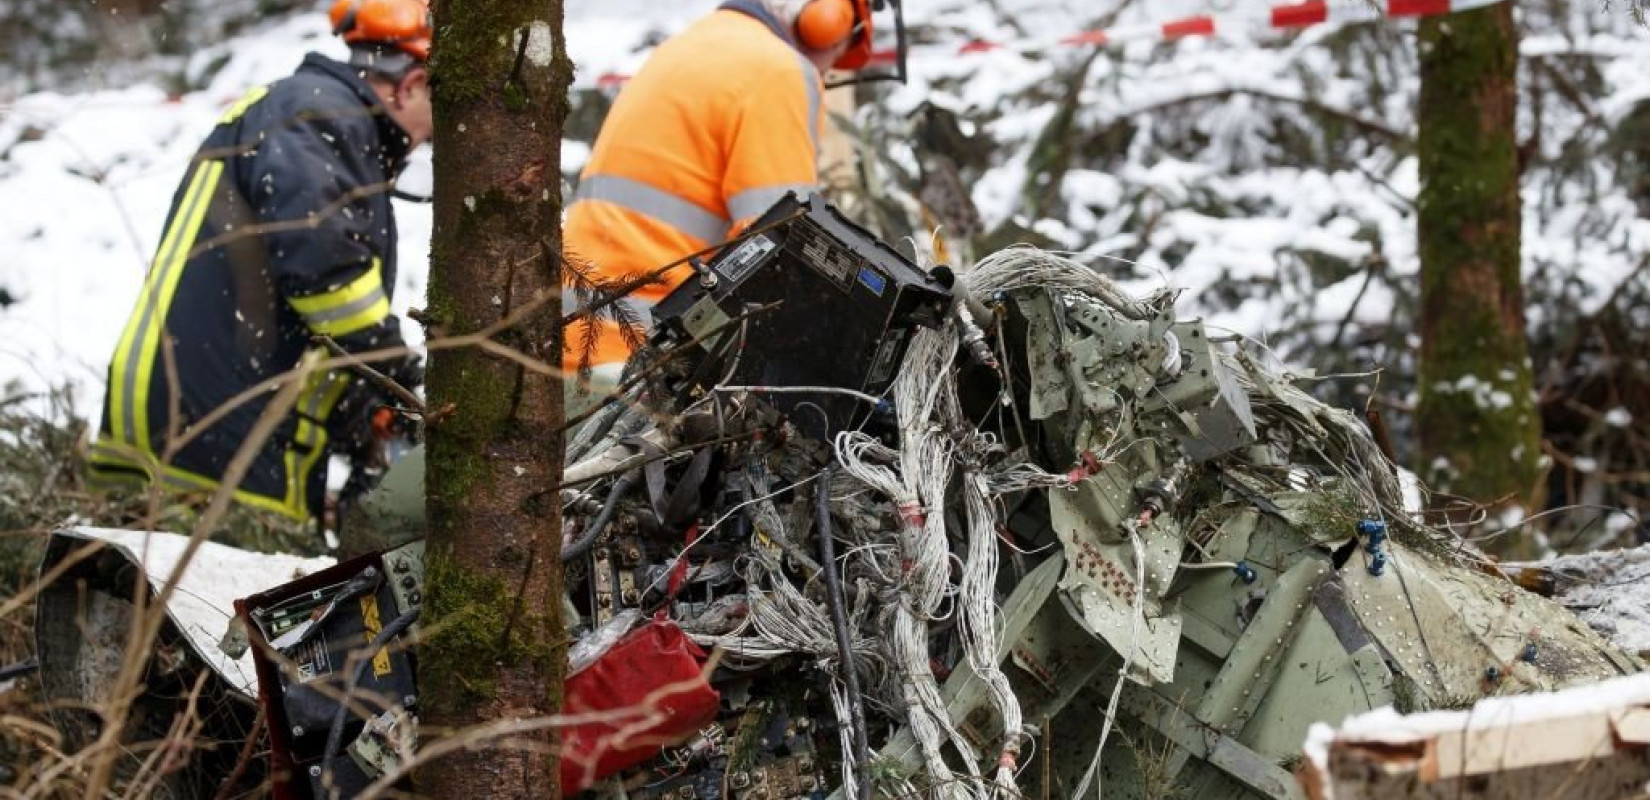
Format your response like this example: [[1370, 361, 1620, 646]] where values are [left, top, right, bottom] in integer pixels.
[[1417, 3, 1541, 508]]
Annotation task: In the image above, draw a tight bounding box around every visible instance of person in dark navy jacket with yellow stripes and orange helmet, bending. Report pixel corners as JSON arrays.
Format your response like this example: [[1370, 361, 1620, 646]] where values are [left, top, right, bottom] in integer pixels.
[[91, 0, 432, 520]]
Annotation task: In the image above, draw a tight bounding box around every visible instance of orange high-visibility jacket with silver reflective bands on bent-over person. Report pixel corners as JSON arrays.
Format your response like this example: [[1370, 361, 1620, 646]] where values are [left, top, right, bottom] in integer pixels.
[[563, 0, 825, 371]]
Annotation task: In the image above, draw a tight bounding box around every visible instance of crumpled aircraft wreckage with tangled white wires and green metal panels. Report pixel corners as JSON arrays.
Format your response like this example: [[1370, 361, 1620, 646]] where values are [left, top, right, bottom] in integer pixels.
[[40, 198, 1642, 800]]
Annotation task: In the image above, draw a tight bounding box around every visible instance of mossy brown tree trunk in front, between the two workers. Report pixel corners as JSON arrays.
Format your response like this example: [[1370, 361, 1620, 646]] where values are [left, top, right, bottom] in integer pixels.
[[417, 0, 573, 798]]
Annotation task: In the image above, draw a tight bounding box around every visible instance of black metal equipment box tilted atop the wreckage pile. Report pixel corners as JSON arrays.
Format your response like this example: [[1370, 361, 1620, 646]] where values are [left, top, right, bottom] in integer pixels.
[[652, 195, 950, 431]]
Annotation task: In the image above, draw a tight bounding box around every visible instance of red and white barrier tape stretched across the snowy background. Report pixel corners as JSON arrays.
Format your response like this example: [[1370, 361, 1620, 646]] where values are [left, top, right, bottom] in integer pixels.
[[574, 0, 1506, 91]]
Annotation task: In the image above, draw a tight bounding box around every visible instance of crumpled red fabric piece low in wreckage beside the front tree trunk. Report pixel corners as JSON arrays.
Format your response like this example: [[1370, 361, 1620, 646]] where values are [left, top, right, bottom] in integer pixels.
[[561, 620, 721, 797]]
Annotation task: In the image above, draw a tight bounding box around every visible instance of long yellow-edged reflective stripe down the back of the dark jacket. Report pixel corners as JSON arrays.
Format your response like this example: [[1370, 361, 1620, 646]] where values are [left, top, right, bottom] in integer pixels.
[[109, 162, 223, 450]]
